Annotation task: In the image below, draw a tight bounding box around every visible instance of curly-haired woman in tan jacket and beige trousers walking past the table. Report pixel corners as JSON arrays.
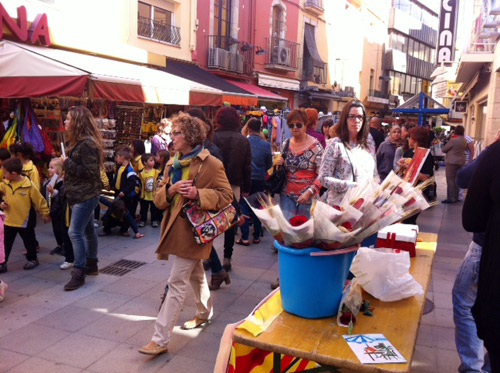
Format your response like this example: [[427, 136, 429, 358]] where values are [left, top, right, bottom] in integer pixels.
[[139, 113, 233, 355]]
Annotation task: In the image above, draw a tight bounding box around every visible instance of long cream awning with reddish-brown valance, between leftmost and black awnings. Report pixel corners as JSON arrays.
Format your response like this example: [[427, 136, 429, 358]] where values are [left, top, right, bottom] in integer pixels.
[[6, 41, 222, 105]]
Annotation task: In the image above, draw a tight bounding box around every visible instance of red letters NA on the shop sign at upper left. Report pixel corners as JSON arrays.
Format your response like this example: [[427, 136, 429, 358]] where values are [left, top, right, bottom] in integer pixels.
[[0, 3, 50, 46]]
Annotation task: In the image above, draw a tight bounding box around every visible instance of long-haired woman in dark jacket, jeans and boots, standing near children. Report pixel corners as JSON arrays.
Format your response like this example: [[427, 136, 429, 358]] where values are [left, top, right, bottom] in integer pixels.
[[64, 106, 104, 290]]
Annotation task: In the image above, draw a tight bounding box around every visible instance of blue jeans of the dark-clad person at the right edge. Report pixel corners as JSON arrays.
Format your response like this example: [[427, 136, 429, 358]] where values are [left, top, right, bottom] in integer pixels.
[[452, 241, 491, 372]]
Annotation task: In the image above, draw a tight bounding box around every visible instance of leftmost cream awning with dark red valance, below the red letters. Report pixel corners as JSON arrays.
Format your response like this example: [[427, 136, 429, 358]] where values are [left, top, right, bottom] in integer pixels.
[[0, 40, 88, 98]]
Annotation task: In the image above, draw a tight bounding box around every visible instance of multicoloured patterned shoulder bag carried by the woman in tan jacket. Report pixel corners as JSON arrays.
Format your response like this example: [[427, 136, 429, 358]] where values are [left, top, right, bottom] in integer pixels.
[[181, 164, 239, 245]]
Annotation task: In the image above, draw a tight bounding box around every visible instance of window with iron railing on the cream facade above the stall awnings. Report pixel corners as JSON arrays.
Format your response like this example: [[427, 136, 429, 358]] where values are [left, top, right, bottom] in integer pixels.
[[137, 1, 181, 45]]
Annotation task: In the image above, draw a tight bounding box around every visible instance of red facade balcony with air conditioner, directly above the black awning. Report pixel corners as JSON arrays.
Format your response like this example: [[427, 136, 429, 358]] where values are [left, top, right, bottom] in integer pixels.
[[207, 35, 253, 75]]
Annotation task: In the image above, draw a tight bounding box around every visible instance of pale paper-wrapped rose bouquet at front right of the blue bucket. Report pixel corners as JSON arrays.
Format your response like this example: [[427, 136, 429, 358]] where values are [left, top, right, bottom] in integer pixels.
[[311, 201, 360, 250]]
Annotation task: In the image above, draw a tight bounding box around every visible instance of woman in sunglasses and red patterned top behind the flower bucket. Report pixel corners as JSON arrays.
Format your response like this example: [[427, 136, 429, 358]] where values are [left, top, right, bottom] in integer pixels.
[[277, 109, 323, 219]]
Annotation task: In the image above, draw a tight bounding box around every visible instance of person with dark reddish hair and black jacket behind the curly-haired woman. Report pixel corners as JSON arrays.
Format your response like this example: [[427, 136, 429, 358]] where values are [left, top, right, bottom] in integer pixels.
[[214, 106, 252, 271]]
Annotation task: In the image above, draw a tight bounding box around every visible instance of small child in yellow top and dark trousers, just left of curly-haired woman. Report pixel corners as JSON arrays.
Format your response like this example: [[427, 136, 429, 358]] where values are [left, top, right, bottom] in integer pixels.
[[139, 153, 161, 228]]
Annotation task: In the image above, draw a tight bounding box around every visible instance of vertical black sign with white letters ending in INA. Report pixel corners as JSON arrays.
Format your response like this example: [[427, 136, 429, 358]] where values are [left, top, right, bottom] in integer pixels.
[[437, 0, 458, 64]]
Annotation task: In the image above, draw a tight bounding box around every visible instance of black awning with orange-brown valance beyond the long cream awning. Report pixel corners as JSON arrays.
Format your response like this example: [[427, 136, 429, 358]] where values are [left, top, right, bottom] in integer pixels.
[[163, 60, 257, 106]]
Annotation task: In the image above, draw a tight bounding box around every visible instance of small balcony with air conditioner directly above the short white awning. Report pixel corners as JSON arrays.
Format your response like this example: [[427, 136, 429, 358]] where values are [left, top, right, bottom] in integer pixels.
[[265, 37, 300, 71]]
